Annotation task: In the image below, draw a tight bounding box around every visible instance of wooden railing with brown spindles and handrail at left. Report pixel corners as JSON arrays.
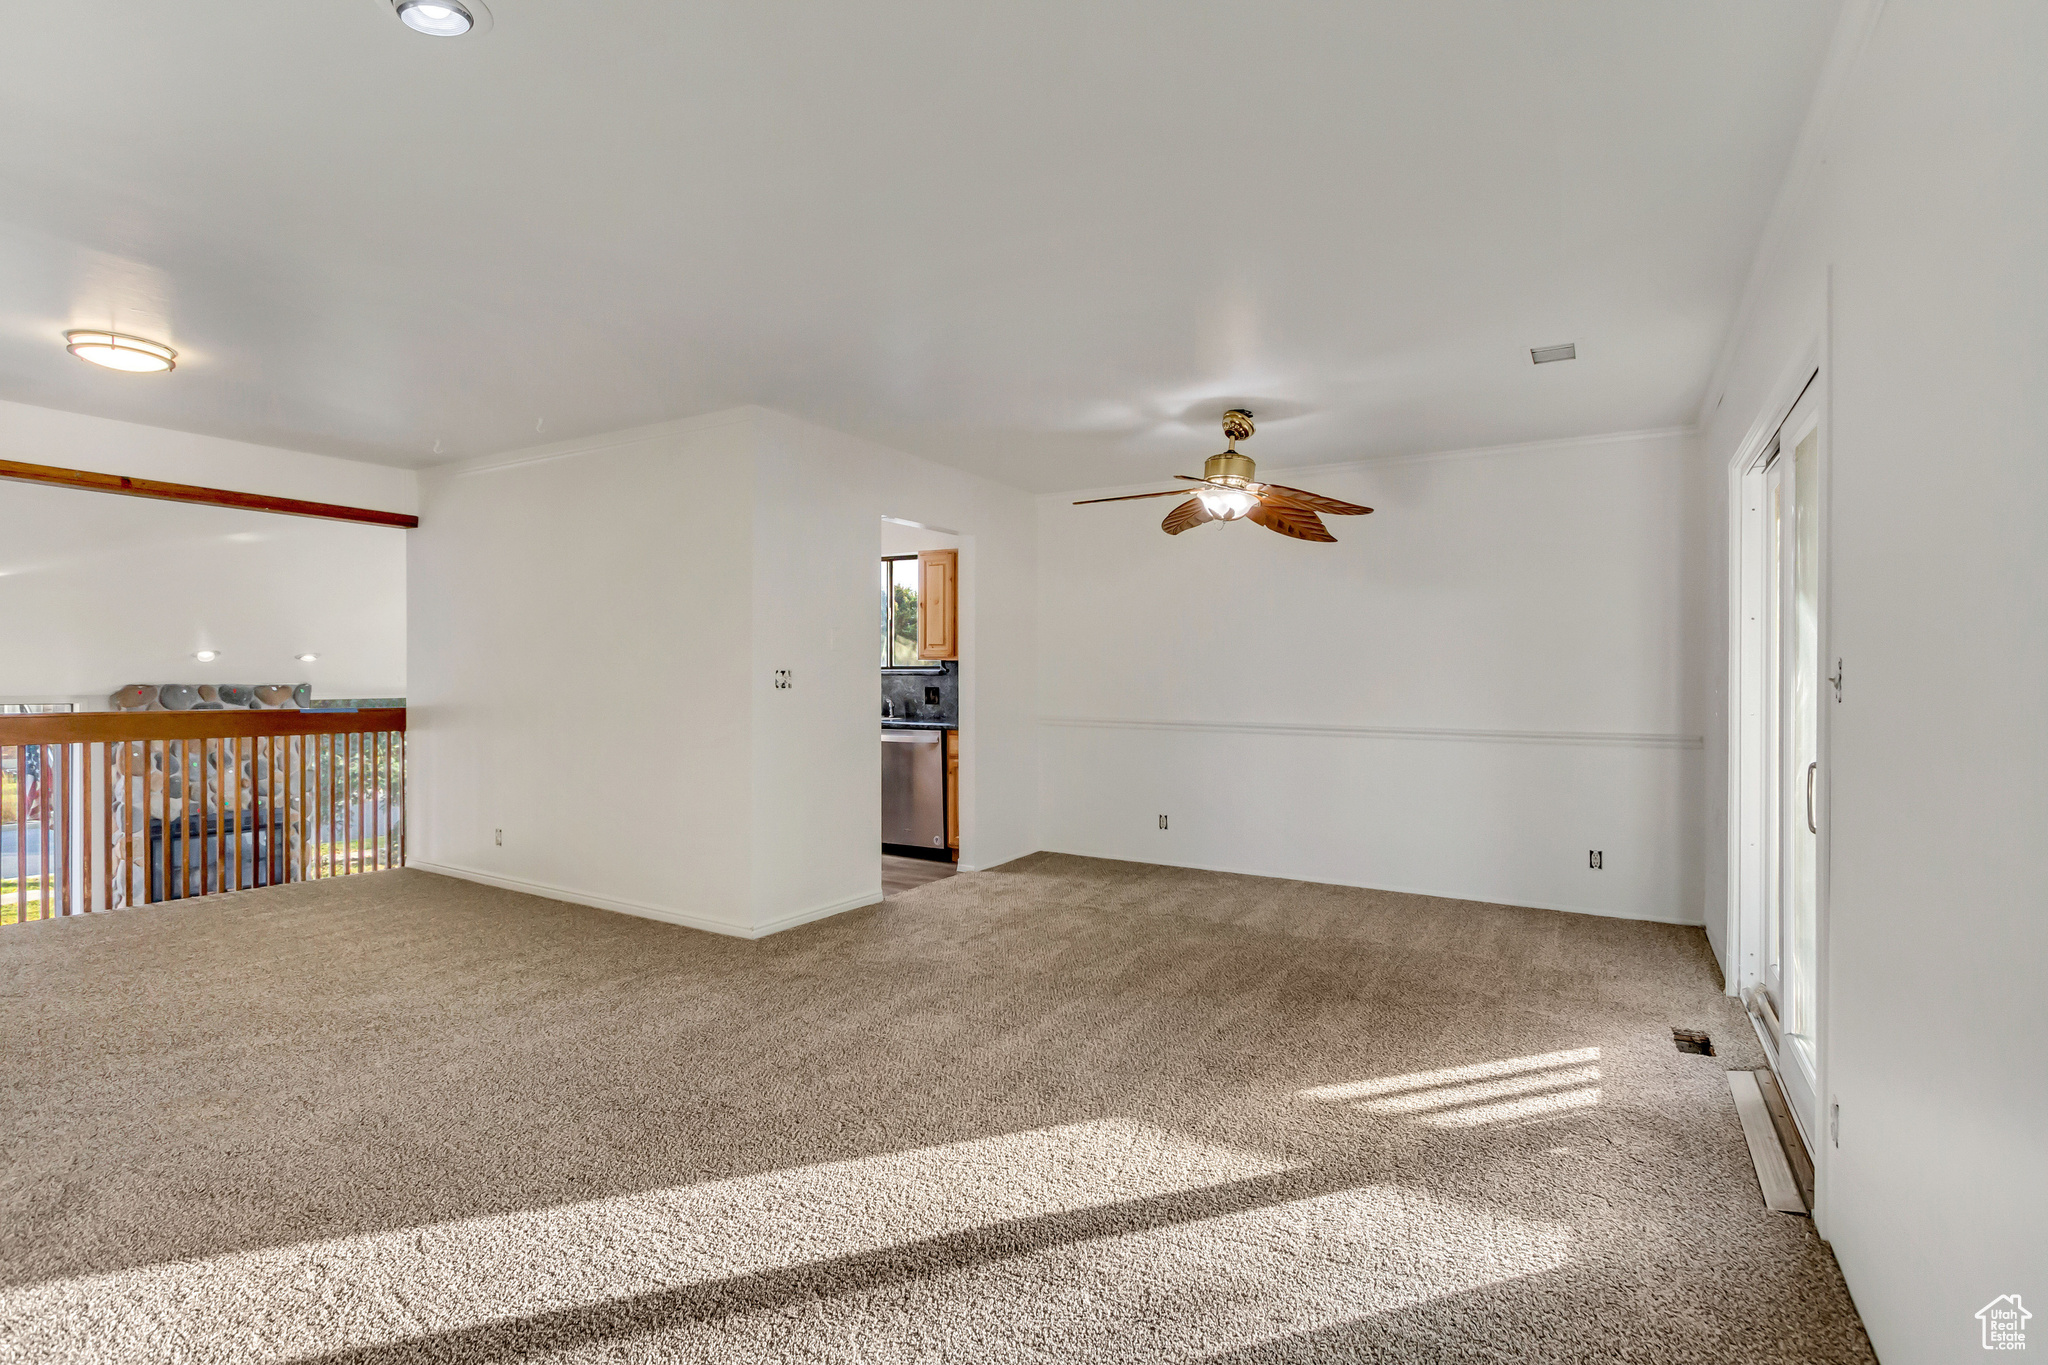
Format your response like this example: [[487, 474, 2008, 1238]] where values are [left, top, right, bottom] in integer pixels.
[[0, 708, 406, 925]]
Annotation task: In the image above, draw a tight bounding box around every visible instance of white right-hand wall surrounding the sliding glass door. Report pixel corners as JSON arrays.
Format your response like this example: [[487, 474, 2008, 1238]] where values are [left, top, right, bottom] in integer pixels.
[[1696, 0, 2048, 1365]]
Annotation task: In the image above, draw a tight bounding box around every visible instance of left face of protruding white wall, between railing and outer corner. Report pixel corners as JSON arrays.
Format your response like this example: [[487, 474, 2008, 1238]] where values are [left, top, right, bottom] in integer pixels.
[[408, 413, 754, 933]]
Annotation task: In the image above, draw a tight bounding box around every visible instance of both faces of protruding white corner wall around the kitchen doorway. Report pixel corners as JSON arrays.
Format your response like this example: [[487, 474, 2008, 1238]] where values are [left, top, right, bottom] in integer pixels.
[[412, 409, 1036, 935]]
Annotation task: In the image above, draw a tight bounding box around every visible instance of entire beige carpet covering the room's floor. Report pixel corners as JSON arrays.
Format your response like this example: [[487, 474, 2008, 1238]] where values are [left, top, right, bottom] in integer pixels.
[[0, 855, 1870, 1365]]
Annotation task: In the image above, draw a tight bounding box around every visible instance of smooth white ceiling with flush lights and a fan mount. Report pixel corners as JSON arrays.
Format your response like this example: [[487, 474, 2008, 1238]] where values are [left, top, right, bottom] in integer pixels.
[[0, 0, 1839, 489]]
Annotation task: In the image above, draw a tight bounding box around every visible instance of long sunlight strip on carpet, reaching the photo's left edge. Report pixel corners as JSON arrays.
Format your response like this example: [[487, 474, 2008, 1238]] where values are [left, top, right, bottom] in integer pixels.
[[0, 1119, 1292, 1361]]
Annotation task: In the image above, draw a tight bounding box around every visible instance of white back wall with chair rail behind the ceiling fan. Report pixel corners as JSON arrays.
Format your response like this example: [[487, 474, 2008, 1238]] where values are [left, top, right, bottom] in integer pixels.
[[1038, 432, 1702, 923]]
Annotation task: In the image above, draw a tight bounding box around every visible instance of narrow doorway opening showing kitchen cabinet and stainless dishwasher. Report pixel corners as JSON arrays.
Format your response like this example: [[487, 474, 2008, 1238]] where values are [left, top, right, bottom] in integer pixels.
[[877, 518, 963, 896]]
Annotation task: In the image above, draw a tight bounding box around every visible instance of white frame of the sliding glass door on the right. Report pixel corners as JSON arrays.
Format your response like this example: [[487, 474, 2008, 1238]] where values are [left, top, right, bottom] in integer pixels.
[[1724, 325, 1839, 1238]]
